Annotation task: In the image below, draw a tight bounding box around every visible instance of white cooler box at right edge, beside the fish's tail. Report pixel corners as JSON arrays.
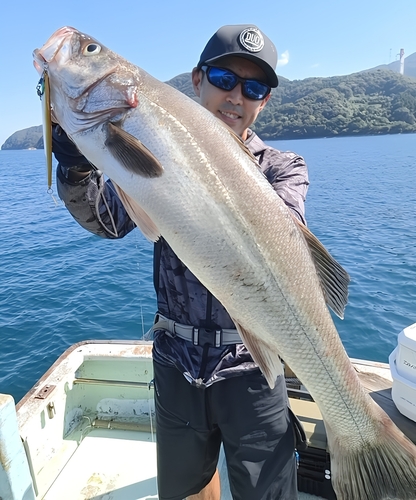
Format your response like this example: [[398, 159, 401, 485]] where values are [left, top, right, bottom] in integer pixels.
[[389, 323, 416, 422]]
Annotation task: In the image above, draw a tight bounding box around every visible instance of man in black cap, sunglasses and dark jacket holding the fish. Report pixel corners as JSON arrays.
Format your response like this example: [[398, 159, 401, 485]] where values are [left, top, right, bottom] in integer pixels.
[[54, 25, 308, 500]]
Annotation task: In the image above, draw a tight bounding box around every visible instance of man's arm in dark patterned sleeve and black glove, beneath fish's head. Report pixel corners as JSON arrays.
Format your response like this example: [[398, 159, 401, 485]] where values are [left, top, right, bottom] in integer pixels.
[[52, 125, 135, 238]]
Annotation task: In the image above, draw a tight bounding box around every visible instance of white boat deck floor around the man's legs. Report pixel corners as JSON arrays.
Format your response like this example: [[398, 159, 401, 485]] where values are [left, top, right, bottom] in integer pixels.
[[43, 428, 320, 500]]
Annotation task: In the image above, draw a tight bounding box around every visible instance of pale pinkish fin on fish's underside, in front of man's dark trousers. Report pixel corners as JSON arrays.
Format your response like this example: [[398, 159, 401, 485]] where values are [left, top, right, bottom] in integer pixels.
[[234, 321, 283, 389]]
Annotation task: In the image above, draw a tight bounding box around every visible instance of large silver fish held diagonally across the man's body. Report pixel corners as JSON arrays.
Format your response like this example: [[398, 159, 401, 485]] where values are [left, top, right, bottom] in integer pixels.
[[34, 27, 416, 500]]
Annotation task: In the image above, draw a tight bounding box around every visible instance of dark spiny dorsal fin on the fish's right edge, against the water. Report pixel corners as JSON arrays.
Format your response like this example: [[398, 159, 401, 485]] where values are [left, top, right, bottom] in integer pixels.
[[293, 217, 350, 319]]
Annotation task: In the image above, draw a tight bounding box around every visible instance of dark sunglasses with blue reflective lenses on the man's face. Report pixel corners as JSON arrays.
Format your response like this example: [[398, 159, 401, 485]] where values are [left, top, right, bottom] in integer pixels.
[[201, 65, 271, 101]]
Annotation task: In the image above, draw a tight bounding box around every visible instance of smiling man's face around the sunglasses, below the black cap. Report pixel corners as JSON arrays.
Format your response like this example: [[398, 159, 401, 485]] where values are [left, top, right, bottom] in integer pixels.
[[192, 56, 270, 140]]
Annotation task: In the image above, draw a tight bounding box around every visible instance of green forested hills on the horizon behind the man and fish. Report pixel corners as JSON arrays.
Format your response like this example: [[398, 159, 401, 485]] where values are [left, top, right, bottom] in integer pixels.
[[2, 68, 416, 149]]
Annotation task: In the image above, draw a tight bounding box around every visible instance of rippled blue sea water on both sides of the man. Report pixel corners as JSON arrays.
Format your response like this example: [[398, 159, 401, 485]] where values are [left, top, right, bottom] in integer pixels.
[[0, 135, 416, 402]]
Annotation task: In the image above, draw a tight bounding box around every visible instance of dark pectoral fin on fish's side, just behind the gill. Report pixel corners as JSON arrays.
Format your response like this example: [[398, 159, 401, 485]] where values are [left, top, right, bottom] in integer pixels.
[[105, 122, 163, 178]]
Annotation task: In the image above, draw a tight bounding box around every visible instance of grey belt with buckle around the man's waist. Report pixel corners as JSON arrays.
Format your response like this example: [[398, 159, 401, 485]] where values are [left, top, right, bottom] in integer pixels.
[[152, 313, 243, 347]]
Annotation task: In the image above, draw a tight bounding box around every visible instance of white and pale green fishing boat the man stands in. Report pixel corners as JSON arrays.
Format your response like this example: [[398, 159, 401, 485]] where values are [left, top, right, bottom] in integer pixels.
[[0, 334, 416, 500]]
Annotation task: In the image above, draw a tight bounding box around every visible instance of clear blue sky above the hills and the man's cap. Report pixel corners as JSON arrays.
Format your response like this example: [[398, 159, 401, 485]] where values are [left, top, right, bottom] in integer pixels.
[[0, 0, 416, 146]]
